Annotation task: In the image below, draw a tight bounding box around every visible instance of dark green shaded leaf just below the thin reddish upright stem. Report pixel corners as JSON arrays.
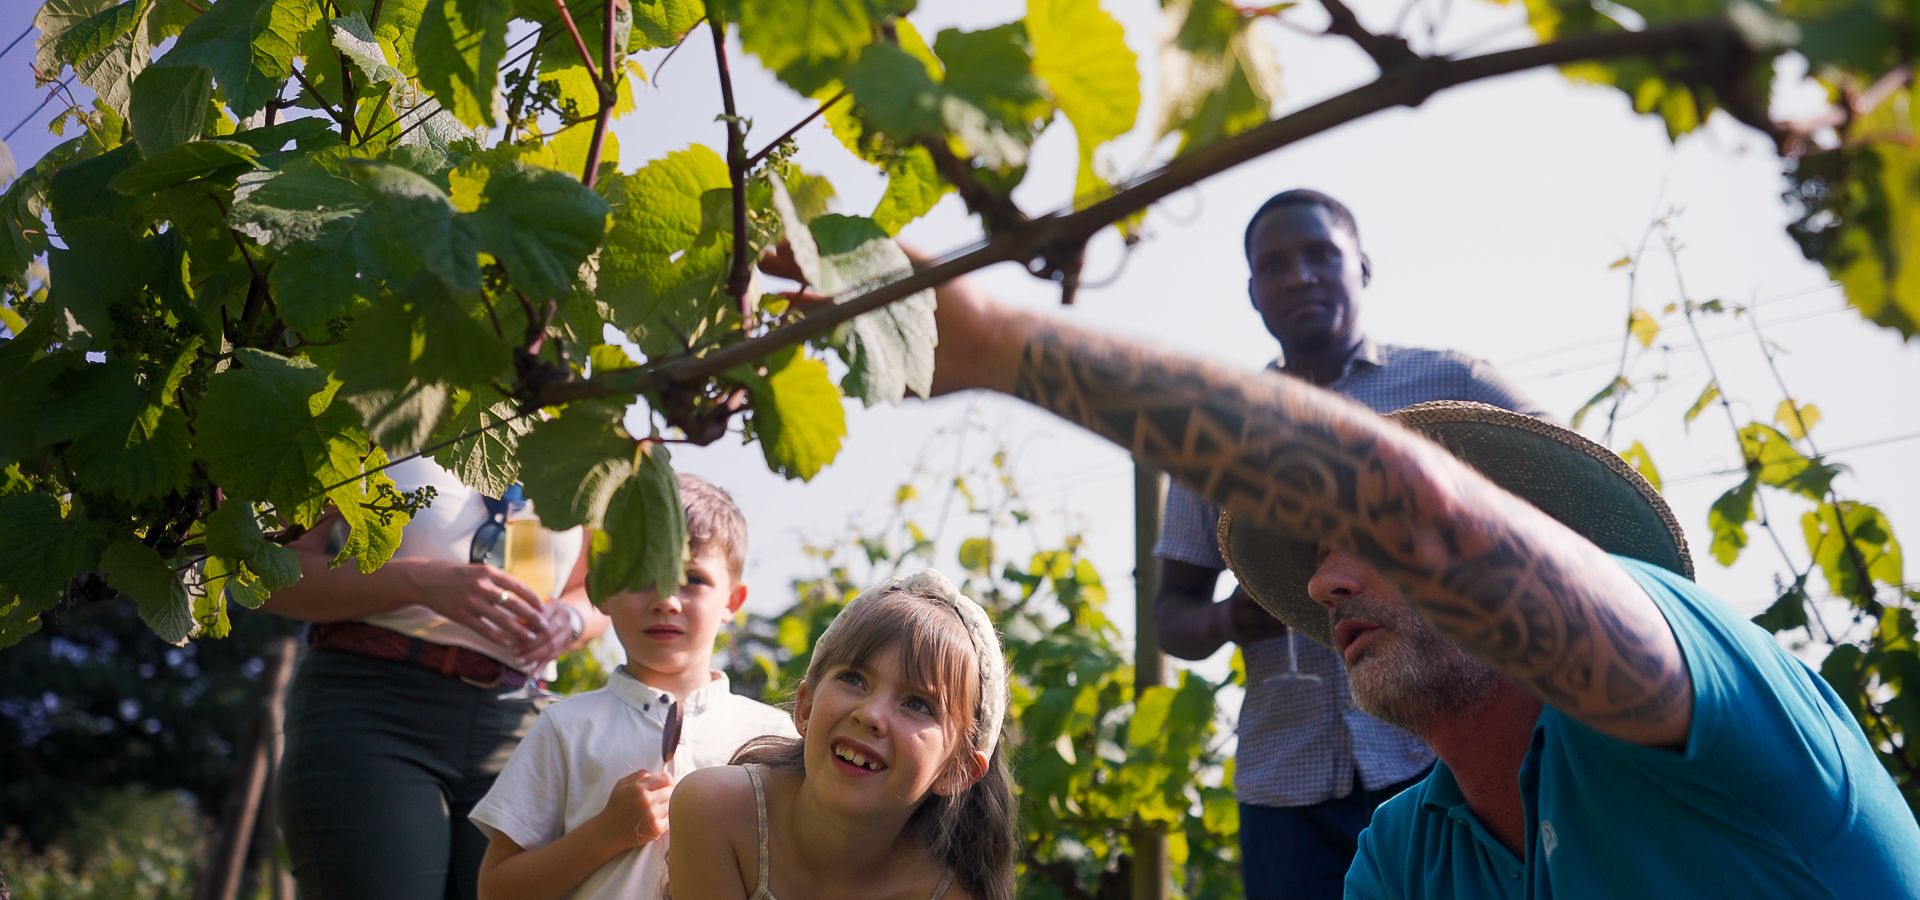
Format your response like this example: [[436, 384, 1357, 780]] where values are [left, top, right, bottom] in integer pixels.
[[472, 163, 607, 297]]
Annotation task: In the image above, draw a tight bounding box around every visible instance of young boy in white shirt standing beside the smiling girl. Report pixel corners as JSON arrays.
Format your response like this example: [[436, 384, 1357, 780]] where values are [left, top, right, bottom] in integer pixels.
[[472, 474, 797, 900]]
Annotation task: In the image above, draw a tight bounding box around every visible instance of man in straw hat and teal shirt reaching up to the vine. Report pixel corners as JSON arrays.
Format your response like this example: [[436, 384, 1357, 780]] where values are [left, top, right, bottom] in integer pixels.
[[910, 255, 1920, 898]]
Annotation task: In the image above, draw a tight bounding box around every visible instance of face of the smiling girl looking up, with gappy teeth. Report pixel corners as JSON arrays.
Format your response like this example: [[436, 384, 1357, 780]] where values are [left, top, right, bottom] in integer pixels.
[[795, 647, 985, 812]]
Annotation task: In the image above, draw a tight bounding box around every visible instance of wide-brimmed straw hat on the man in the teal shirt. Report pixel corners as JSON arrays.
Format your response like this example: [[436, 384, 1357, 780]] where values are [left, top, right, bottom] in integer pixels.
[[1219, 401, 1693, 647]]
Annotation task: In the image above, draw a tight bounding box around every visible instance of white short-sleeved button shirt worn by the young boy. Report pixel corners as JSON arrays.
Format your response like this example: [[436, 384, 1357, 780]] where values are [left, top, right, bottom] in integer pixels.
[[470, 668, 797, 898]]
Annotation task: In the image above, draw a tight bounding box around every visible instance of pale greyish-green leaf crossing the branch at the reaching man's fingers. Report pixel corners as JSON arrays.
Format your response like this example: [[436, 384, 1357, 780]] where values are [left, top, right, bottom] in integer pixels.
[[812, 215, 939, 407]]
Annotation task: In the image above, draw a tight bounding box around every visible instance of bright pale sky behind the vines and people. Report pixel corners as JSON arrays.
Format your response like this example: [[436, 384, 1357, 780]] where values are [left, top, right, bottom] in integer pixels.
[[0, 0, 1920, 666]]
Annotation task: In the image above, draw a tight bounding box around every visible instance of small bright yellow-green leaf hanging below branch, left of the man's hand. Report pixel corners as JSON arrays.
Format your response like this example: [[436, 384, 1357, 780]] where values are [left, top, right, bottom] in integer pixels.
[[747, 347, 847, 482]]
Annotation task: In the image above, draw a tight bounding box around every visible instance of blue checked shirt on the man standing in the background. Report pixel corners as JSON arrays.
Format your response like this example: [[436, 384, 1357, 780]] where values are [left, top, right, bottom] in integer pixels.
[[1154, 342, 1542, 806]]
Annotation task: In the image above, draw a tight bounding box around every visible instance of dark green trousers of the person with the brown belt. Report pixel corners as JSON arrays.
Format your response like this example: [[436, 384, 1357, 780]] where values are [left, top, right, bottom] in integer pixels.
[[278, 651, 540, 900]]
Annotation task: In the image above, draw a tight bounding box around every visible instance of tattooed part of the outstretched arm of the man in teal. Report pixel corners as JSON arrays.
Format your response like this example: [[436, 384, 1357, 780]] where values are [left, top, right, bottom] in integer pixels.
[[1014, 326, 1692, 743]]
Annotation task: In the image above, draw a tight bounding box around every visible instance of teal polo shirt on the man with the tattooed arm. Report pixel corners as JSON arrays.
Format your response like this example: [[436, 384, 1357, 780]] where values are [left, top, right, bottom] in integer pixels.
[[1346, 557, 1920, 900]]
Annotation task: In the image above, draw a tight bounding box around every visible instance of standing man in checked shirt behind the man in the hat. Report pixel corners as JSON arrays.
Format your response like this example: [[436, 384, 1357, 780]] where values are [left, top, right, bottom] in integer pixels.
[[1154, 190, 1528, 900]]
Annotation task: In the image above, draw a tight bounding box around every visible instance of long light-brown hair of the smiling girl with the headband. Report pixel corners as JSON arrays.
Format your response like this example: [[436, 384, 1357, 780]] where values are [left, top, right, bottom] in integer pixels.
[[732, 593, 1018, 900]]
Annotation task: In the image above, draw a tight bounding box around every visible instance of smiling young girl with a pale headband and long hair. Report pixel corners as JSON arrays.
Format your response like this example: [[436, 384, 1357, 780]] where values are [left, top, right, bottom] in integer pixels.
[[668, 570, 1016, 900]]
